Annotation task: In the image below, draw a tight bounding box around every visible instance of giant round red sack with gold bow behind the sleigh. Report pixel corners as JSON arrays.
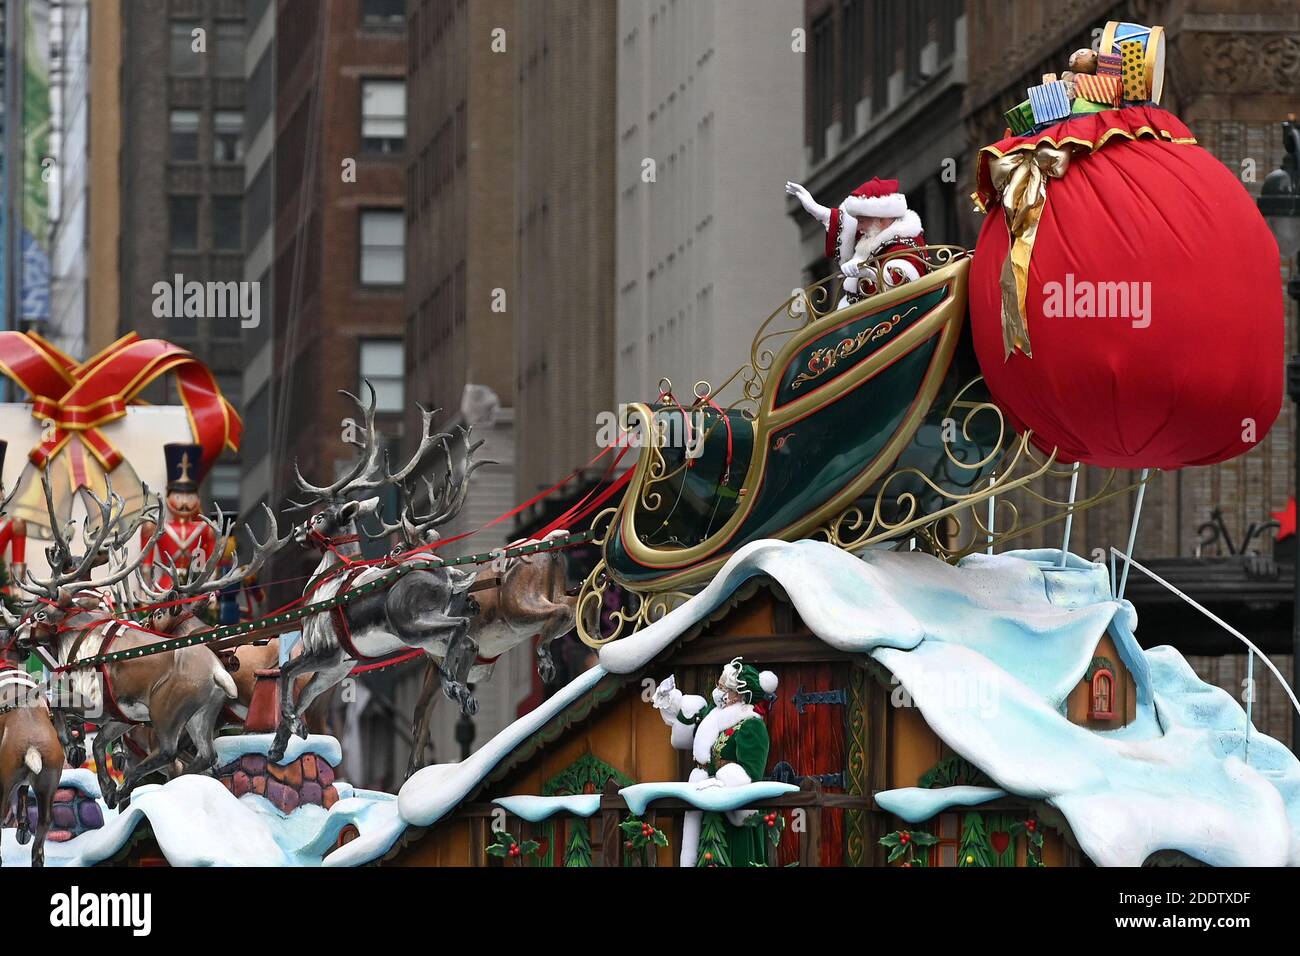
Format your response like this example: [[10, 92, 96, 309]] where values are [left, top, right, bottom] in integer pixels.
[[970, 105, 1283, 468]]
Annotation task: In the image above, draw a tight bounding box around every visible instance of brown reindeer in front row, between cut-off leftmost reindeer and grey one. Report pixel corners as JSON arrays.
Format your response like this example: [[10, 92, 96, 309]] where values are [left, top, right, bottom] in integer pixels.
[[5, 473, 235, 806]]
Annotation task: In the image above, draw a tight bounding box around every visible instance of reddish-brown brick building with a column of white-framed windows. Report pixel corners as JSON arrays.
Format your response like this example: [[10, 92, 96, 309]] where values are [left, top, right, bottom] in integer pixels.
[[242, 0, 406, 554]]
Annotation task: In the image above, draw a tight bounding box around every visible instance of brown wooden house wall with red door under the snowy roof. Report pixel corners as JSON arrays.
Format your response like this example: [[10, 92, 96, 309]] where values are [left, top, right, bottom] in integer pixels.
[[395, 587, 1136, 866]]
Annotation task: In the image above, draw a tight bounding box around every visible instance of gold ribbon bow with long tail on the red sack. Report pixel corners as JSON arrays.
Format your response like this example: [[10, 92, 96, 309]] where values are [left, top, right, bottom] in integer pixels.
[[988, 143, 1070, 358]]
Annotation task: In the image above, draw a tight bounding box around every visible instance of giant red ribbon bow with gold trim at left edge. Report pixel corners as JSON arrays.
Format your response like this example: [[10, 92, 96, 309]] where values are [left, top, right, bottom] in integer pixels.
[[0, 332, 243, 471]]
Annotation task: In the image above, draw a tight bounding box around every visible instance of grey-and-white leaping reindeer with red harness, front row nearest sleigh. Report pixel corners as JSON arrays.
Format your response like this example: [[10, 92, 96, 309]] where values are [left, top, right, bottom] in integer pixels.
[[269, 382, 488, 760]]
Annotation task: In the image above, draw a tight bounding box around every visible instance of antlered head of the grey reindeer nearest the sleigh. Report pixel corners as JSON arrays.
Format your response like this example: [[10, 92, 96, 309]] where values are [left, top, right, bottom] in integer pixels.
[[290, 381, 491, 551]]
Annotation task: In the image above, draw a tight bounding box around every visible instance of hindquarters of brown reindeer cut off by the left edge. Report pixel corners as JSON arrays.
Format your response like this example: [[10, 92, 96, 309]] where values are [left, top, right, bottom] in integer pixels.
[[0, 663, 64, 866]]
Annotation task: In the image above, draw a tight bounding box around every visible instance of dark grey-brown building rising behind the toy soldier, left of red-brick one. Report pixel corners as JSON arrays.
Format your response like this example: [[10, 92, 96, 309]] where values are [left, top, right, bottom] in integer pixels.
[[118, 0, 246, 510]]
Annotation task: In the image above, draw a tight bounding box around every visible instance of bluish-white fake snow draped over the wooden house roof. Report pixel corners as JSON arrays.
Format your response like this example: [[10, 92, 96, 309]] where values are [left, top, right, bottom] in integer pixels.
[[4, 541, 1300, 866]]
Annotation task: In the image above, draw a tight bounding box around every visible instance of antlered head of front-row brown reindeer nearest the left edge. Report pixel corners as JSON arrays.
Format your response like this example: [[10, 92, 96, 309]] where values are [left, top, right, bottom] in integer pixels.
[[0, 472, 163, 649]]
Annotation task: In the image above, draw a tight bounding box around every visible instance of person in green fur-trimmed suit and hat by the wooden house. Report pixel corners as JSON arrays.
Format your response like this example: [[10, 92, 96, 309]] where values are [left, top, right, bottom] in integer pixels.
[[653, 657, 776, 866]]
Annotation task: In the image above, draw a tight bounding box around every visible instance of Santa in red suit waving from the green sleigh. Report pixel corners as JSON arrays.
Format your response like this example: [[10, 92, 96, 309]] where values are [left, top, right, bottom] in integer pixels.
[[785, 179, 927, 308]]
